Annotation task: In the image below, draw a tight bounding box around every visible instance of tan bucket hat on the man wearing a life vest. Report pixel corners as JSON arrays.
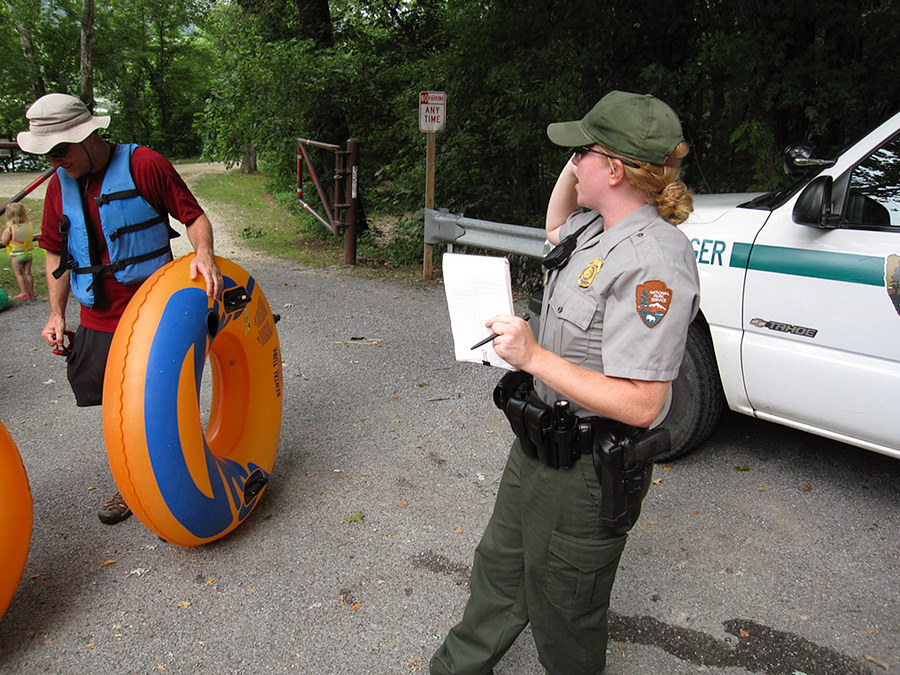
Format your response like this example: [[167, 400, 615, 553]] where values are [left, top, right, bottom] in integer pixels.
[[16, 94, 109, 155]]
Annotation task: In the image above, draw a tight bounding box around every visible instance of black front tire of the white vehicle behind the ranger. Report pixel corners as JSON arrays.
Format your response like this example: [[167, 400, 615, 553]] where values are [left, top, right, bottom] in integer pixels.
[[656, 320, 725, 462]]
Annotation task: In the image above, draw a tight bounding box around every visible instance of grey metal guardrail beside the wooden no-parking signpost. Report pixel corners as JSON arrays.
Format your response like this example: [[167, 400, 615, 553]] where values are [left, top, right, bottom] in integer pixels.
[[425, 209, 546, 258]]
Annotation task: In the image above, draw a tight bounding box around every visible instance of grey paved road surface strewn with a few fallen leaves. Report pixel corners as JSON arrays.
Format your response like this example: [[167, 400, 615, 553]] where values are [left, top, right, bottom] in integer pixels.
[[0, 166, 900, 675]]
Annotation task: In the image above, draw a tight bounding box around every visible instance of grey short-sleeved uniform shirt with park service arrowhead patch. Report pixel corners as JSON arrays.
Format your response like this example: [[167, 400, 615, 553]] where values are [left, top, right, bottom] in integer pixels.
[[535, 205, 700, 414]]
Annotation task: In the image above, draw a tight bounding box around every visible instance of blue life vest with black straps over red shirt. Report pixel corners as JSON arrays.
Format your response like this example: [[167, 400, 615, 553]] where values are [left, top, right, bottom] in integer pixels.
[[53, 144, 178, 307]]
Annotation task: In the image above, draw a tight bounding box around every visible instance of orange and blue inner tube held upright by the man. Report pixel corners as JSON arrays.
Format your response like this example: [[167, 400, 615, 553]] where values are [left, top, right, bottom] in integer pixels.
[[103, 254, 283, 546]]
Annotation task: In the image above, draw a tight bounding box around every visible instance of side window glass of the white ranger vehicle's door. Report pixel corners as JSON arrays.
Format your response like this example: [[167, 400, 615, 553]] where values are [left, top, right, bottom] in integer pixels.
[[844, 135, 900, 229]]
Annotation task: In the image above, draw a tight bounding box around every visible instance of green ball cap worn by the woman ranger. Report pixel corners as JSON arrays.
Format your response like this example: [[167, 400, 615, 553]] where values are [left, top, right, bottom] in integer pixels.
[[547, 91, 684, 166]]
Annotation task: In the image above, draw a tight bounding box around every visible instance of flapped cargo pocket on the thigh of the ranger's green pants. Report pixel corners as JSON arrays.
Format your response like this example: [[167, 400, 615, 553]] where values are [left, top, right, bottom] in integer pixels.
[[544, 532, 627, 612]]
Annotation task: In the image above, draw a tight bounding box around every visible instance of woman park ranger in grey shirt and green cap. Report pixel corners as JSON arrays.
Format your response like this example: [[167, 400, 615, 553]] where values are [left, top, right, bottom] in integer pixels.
[[431, 91, 699, 675]]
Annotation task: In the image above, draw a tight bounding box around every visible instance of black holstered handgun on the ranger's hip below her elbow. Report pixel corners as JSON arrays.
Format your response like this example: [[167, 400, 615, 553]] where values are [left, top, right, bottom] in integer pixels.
[[594, 428, 669, 529]]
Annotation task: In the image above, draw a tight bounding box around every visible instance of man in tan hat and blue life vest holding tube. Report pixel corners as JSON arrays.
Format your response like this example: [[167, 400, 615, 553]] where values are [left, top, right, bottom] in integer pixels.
[[17, 94, 222, 525]]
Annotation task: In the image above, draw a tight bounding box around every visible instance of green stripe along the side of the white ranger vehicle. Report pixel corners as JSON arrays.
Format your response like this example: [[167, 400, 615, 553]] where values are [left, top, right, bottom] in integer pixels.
[[730, 243, 884, 286]]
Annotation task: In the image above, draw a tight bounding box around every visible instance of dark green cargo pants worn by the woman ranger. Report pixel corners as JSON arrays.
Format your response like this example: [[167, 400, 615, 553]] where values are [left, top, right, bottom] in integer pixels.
[[431, 441, 628, 675]]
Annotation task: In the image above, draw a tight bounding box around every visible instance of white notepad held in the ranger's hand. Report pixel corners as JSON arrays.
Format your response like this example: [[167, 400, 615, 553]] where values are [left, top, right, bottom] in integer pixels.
[[443, 253, 515, 370]]
